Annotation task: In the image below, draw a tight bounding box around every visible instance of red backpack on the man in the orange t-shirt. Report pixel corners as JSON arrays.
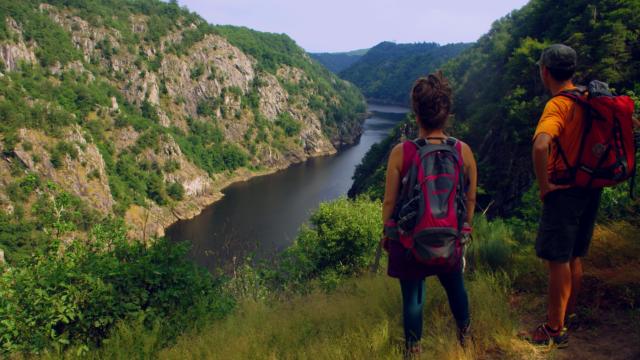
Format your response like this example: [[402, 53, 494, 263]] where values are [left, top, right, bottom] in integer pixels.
[[556, 80, 636, 193]]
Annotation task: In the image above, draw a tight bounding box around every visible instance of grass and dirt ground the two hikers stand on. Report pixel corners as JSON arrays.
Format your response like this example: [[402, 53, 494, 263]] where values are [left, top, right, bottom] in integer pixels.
[[57, 223, 640, 360]]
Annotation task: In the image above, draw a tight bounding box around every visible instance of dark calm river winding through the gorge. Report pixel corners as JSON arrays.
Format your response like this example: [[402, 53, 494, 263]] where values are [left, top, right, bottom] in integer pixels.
[[166, 104, 408, 271]]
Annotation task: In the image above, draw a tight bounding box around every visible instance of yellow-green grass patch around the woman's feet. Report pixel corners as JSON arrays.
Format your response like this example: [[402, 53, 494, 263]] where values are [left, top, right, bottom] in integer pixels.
[[159, 273, 535, 359]]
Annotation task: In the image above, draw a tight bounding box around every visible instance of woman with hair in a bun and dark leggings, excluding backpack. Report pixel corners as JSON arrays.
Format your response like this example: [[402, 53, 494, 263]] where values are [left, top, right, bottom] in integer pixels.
[[382, 72, 477, 356]]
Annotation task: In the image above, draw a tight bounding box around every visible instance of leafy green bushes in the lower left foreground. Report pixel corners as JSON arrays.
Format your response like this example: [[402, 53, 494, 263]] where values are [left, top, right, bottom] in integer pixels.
[[0, 220, 233, 352]]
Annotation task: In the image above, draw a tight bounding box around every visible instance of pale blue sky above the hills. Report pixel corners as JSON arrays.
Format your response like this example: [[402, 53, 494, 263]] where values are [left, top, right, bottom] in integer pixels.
[[178, 0, 528, 52]]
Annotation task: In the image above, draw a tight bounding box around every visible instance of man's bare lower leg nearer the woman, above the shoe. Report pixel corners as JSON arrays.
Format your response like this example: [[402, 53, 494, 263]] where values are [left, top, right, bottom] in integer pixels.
[[547, 261, 572, 330]]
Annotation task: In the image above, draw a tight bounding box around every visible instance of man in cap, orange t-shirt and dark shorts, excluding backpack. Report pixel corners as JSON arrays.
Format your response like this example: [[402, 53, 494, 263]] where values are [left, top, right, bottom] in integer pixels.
[[530, 44, 602, 347]]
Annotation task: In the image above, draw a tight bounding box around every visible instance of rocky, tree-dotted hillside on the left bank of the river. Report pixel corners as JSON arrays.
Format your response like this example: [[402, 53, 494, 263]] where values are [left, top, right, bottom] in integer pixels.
[[0, 0, 365, 250]]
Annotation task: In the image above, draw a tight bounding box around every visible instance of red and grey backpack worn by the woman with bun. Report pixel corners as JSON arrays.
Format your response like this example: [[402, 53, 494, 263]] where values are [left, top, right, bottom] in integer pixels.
[[386, 138, 466, 272]]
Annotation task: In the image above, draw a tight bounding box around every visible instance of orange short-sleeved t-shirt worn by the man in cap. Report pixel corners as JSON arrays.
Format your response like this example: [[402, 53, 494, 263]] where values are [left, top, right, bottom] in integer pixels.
[[533, 88, 584, 182]]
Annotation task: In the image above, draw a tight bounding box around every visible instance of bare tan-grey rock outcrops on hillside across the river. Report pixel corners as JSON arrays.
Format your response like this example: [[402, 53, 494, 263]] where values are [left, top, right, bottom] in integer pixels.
[[0, 4, 359, 240]]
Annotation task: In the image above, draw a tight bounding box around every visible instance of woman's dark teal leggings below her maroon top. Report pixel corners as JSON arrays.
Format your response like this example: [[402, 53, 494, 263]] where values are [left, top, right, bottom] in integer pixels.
[[400, 271, 469, 346]]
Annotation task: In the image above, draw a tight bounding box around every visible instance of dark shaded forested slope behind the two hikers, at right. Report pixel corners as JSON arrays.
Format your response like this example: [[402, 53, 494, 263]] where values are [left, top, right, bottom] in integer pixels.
[[352, 0, 640, 216]]
